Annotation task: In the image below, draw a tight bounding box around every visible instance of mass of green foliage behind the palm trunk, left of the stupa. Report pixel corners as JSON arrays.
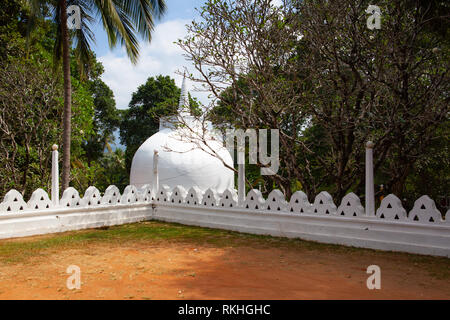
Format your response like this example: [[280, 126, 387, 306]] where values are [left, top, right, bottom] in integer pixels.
[[0, 0, 127, 197]]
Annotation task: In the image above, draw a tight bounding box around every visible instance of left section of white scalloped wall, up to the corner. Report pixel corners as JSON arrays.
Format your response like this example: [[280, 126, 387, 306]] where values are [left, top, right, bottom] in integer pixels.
[[0, 186, 152, 239]]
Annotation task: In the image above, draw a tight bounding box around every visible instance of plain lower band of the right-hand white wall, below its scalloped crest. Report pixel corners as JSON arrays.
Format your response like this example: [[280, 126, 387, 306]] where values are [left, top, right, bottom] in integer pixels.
[[153, 204, 450, 257]]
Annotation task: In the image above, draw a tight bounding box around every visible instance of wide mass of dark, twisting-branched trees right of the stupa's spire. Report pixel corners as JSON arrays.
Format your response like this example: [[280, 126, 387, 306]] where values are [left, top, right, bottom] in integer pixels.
[[179, 0, 450, 205]]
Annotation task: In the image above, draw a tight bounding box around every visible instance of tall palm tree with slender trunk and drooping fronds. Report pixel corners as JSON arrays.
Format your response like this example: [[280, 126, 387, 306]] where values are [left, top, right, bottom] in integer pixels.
[[28, 0, 166, 190]]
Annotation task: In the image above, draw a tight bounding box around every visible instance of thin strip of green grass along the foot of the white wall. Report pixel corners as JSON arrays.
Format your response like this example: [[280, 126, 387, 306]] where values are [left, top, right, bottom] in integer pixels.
[[0, 221, 450, 279]]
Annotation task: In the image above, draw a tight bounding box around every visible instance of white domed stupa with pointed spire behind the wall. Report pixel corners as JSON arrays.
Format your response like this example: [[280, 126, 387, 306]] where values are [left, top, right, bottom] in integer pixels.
[[130, 77, 234, 193]]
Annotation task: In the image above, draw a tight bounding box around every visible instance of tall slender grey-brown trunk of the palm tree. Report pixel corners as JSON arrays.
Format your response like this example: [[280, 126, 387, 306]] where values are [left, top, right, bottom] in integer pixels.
[[60, 0, 72, 190]]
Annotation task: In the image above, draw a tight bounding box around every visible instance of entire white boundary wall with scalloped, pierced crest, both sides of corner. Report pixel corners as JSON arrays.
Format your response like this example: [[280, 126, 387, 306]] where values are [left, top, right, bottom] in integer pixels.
[[0, 186, 450, 257]]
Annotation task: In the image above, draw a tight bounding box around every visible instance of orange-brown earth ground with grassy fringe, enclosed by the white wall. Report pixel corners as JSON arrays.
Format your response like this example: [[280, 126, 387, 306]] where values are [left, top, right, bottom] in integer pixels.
[[0, 222, 450, 299]]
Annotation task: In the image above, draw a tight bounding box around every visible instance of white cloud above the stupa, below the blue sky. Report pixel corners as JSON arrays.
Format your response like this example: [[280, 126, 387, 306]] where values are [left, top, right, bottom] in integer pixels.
[[99, 19, 208, 109]]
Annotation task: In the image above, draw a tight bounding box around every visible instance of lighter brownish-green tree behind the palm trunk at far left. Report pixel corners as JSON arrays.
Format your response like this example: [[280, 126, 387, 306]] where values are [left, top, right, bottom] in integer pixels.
[[0, 59, 94, 195]]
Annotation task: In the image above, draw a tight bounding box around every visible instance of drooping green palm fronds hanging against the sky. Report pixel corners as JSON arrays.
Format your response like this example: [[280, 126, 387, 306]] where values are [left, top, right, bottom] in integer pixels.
[[24, 0, 166, 77]]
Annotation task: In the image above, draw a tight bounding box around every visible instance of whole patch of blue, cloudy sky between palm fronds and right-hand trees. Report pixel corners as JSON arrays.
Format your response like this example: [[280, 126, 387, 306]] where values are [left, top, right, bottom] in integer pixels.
[[93, 0, 208, 109]]
